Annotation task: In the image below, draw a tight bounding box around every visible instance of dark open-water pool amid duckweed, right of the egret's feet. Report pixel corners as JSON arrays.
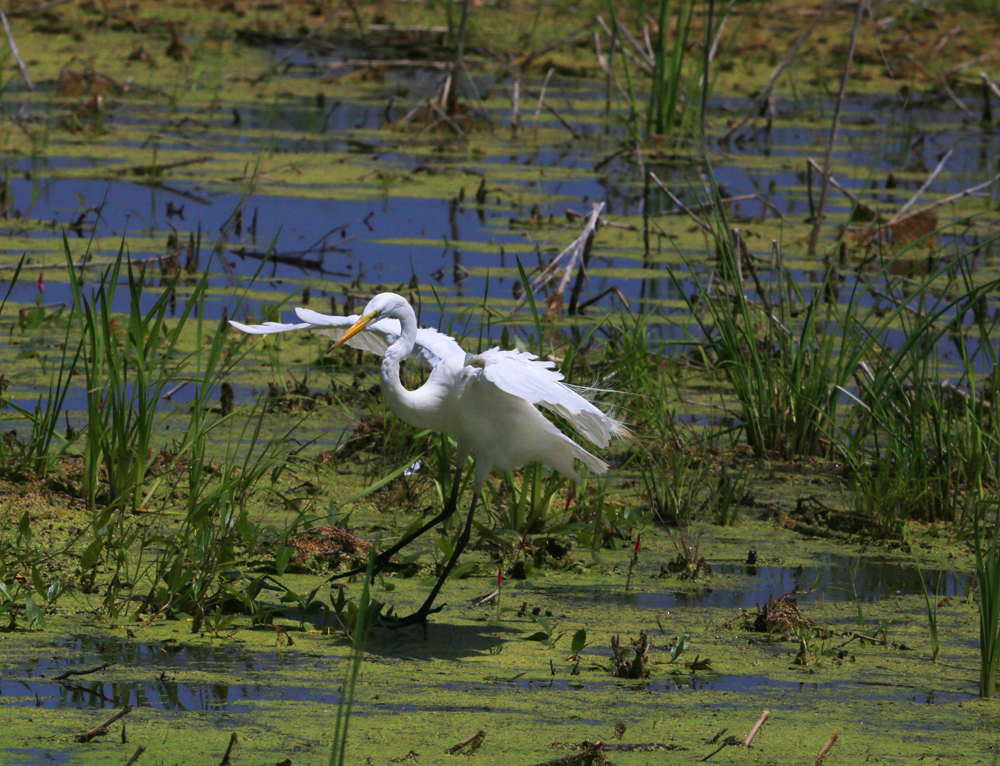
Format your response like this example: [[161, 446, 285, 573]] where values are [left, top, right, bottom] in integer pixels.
[[559, 554, 971, 609]]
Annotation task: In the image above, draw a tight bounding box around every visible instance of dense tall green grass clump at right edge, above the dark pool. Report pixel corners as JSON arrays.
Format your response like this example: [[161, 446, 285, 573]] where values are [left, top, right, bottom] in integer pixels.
[[846, 259, 1000, 534]]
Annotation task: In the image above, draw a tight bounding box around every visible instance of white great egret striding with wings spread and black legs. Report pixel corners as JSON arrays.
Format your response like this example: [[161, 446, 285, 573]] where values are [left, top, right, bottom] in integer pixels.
[[230, 293, 627, 624]]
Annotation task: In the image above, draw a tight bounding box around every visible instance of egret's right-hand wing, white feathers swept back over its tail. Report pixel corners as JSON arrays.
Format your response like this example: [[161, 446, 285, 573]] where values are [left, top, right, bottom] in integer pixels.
[[469, 348, 627, 447]]
